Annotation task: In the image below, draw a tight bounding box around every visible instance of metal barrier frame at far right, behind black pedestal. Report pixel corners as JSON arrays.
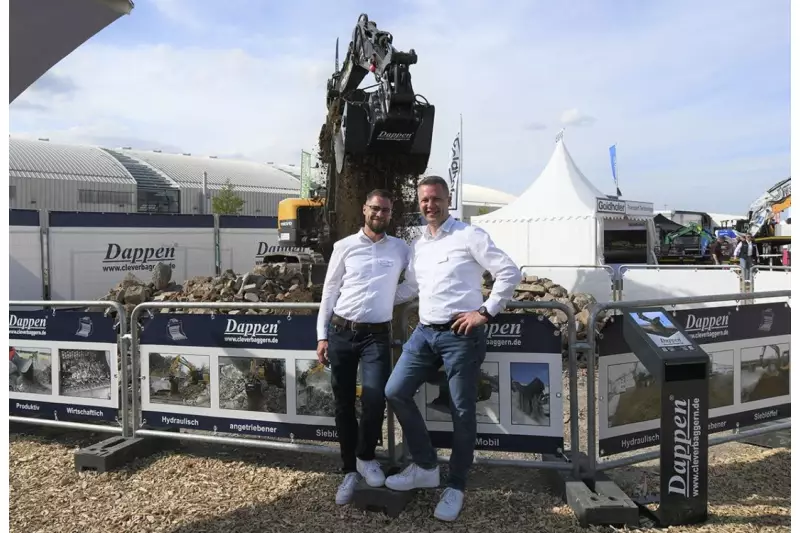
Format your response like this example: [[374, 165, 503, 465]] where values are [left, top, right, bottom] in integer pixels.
[[576, 290, 791, 479]]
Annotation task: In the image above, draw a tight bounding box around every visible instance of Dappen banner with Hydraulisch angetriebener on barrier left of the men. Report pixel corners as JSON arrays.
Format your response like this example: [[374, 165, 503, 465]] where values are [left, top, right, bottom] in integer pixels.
[[139, 313, 382, 441]]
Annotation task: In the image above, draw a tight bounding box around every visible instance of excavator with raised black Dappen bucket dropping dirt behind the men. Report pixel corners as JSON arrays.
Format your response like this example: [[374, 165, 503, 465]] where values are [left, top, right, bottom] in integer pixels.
[[270, 14, 435, 264]]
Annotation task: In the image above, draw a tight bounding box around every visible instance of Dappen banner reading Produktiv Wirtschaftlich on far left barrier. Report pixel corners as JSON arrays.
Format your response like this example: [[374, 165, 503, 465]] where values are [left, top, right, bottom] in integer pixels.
[[9, 311, 120, 422]]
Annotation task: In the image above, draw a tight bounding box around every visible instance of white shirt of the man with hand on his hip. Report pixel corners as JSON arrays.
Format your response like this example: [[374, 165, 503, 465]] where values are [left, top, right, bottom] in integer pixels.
[[395, 217, 522, 324]]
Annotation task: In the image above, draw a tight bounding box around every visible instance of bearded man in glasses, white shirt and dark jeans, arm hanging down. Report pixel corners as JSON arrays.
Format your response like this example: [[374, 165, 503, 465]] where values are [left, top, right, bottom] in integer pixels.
[[317, 190, 410, 505]]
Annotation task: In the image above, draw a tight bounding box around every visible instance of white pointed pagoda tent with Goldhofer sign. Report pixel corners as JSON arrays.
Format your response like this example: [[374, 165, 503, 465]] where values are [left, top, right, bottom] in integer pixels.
[[470, 136, 653, 267]]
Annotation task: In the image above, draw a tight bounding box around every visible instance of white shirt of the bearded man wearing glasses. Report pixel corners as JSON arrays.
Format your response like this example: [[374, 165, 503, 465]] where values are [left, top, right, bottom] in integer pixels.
[[317, 229, 411, 340]]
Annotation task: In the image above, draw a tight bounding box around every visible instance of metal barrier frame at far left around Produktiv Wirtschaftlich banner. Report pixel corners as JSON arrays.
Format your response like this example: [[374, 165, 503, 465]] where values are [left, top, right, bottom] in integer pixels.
[[9, 300, 131, 437]]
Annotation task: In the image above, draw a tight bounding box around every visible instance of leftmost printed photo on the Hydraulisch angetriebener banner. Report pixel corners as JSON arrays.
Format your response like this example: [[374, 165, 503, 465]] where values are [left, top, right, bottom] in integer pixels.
[[148, 352, 211, 407]]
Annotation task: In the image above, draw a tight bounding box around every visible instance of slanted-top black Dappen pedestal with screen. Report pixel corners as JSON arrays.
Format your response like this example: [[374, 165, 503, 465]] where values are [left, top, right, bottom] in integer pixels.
[[623, 307, 711, 527]]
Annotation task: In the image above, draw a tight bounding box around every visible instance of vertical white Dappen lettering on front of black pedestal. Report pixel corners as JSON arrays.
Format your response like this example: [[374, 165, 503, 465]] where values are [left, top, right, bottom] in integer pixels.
[[669, 396, 702, 498]]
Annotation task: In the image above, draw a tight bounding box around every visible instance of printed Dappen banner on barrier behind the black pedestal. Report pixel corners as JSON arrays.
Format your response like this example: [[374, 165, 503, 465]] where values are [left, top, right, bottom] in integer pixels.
[[598, 302, 791, 457]]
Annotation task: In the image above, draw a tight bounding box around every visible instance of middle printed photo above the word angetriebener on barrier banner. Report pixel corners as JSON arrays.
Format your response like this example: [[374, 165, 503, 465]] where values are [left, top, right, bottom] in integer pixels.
[[219, 357, 287, 414]]
